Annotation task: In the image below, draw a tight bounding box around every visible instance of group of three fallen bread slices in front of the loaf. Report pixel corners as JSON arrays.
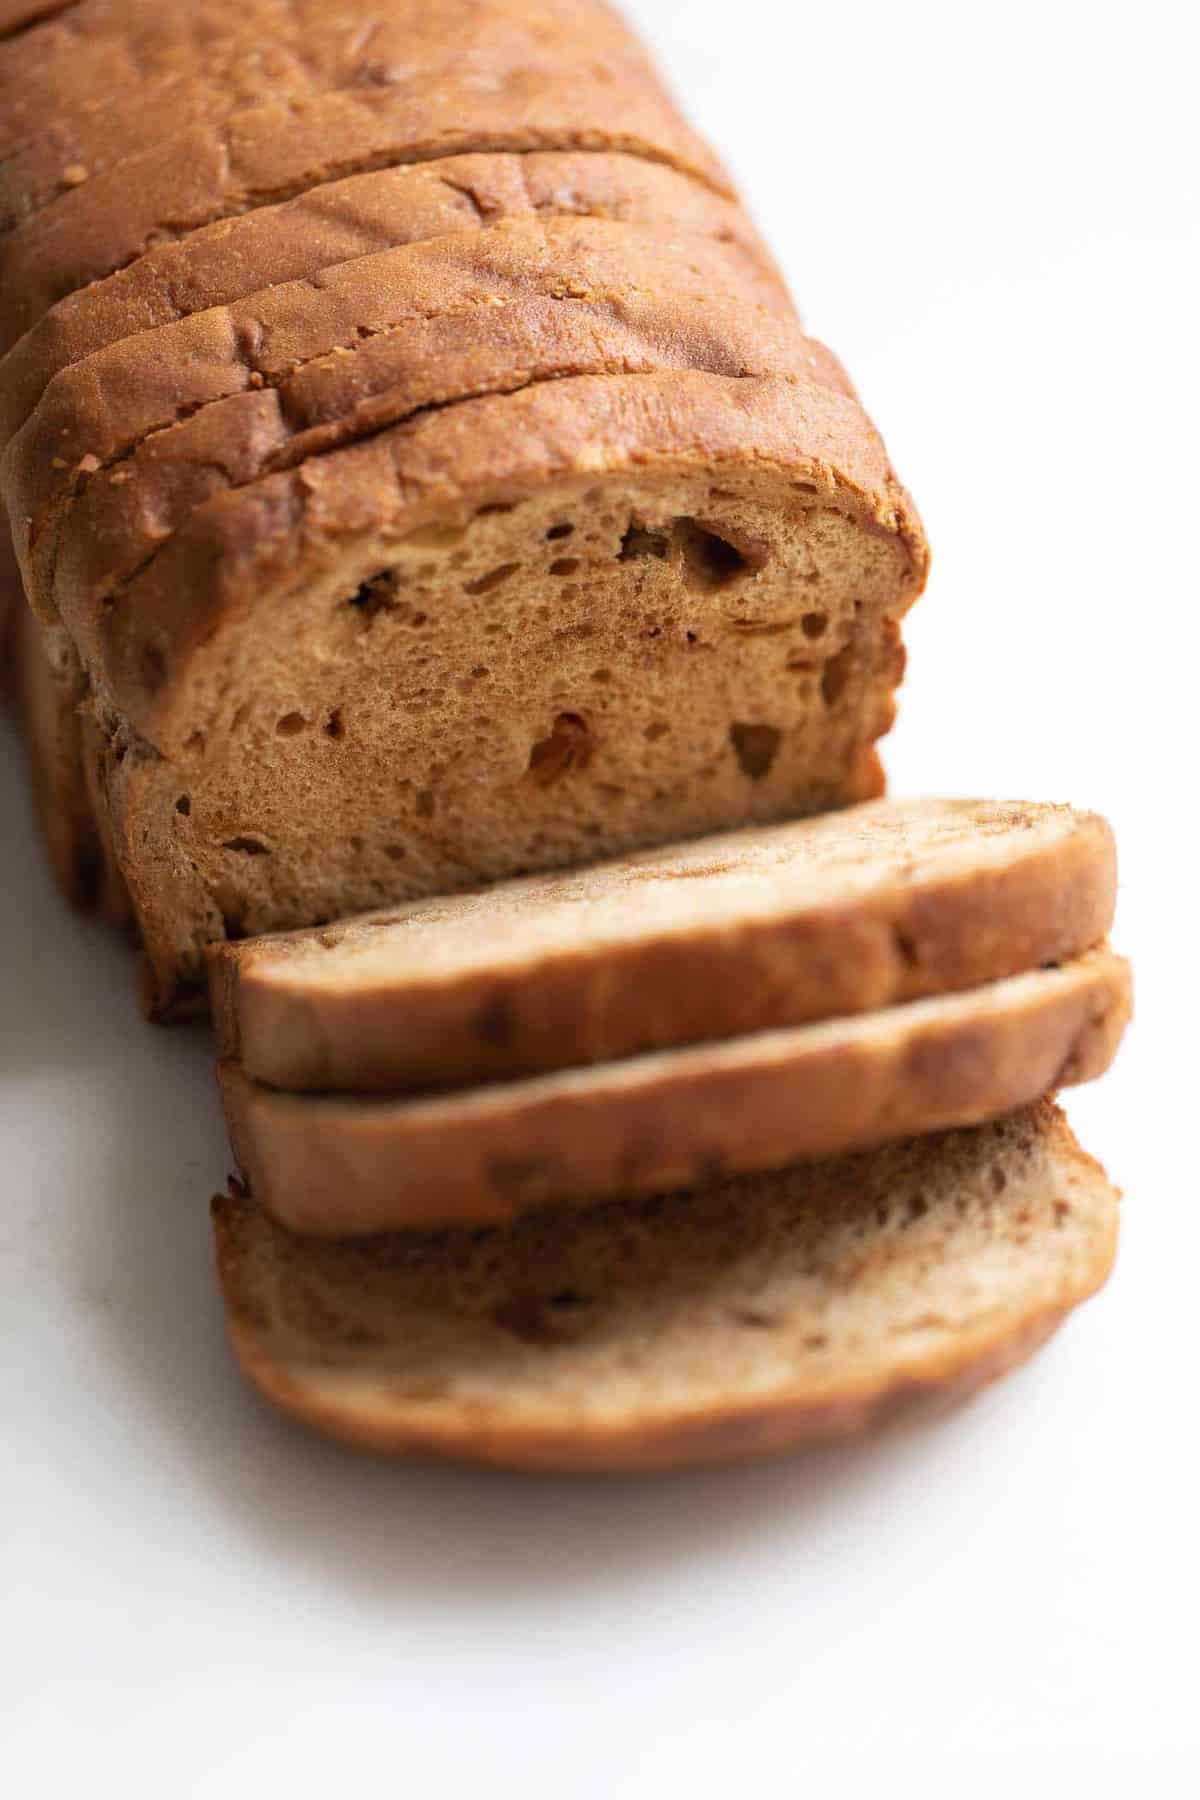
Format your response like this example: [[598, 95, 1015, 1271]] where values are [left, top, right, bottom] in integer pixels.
[[212, 801, 1130, 1469]]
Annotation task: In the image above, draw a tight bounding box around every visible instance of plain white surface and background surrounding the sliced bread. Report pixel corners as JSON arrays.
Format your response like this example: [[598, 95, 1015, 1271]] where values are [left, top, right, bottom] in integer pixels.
[[0, 0, 1200, 1800]]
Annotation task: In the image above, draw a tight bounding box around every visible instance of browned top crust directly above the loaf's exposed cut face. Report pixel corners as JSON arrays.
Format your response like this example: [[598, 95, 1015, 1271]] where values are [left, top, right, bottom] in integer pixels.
[[86, 371, 928, 751]]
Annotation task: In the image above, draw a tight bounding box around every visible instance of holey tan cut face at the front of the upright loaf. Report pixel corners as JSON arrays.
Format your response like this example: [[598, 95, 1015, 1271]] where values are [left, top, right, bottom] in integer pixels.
[[110, 473, 914, 1004]]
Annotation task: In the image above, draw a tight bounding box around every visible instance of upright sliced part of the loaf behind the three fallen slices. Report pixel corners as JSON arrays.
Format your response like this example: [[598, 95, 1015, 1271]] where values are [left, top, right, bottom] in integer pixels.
[[0, 0, 927, 1013]]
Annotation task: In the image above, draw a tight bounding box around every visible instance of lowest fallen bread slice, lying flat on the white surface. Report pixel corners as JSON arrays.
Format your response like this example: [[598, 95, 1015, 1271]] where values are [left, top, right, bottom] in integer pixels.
[[214, 1103, 1117, 1472]]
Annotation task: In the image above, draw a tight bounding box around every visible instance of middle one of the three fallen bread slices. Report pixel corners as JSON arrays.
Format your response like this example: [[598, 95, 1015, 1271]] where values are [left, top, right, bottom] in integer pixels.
[[221, 950, 1132, 1237]]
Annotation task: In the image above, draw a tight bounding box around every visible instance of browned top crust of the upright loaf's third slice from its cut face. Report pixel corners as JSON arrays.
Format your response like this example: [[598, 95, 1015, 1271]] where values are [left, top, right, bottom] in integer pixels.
[[4, 214, 816, 576]]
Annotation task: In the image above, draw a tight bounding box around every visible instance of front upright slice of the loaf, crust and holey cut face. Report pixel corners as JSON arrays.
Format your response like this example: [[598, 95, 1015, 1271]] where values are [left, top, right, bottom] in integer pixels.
[[84, 371, 927, 1010]]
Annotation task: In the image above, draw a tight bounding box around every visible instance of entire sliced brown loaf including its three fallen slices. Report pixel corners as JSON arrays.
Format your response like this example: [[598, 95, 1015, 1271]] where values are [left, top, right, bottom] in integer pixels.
[[0, 0, 1128, 1467]]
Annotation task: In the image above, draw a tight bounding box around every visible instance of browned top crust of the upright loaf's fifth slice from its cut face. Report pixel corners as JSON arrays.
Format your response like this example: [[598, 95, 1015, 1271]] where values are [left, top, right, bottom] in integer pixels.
[[0, 22, 729, 349]]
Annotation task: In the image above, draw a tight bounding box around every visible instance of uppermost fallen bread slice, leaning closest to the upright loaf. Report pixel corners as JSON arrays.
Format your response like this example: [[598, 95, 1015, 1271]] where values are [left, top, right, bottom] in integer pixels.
[[210, 799, 1115, 1093]]
